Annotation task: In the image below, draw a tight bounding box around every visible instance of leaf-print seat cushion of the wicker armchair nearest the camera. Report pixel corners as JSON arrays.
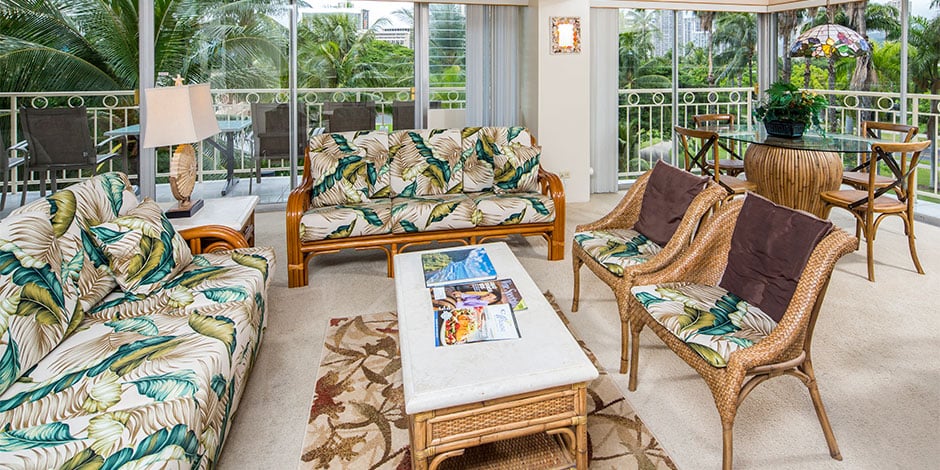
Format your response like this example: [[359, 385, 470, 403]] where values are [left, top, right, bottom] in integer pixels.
[[631, 283, 777, 367]]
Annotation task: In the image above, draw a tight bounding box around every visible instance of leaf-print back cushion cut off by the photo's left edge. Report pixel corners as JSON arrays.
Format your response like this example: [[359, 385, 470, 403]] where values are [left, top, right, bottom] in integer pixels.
[[0, 212, 78, 392]]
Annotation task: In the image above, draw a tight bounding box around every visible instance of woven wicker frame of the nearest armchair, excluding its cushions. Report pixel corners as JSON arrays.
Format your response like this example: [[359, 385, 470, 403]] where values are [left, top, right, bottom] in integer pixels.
[[629, 196, 858, 469]]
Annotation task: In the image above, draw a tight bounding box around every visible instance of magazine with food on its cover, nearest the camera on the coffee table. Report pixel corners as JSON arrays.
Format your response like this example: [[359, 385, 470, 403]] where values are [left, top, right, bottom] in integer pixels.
[[434, 304, 522, 346]]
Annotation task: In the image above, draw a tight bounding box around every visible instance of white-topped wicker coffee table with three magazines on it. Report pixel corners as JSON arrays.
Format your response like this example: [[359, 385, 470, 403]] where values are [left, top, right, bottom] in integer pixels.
[[395, 243, 598, 470]]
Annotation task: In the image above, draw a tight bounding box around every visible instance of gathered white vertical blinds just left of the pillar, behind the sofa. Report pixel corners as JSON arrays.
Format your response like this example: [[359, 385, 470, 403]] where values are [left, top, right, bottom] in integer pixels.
[[467, 5, 522, 126]]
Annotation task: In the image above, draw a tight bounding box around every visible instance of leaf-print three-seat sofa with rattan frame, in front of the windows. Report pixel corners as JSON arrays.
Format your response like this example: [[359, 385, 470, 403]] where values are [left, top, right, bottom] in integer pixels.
[[287, 127, 565, 287]]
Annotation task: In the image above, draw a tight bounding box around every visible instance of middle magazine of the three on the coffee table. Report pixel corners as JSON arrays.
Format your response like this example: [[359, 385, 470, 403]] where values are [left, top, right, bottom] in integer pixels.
[[430, 279, 526, 312]]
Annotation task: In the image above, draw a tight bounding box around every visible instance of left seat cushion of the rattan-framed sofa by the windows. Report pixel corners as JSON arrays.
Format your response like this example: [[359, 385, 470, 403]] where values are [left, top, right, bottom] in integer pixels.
[[300, 198, 392, 242]]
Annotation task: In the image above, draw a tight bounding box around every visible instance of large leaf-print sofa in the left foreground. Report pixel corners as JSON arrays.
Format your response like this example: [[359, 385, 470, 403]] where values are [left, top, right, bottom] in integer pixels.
[[0, 173, 274, 469]]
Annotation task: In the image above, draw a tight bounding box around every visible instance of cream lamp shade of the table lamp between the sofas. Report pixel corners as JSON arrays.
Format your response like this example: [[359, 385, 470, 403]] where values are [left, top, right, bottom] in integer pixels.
[[141, 83, 219, 148]]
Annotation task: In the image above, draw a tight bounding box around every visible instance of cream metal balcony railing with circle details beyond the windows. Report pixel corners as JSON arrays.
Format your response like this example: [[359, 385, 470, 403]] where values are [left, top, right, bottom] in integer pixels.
[[0, 87, 940, 202]]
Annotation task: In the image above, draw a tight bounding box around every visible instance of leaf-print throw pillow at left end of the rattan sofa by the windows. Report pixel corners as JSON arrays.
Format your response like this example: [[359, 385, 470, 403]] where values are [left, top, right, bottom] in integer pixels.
[[309, 150, 369, 207]]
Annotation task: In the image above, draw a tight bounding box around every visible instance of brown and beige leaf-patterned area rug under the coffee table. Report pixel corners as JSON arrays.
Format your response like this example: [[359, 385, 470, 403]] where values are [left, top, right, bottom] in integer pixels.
[[299, 293, 676, 470]]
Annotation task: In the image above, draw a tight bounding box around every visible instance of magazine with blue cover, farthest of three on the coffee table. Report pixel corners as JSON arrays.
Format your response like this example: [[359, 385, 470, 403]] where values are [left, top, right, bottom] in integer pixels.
[[421, 247, 496, 287]]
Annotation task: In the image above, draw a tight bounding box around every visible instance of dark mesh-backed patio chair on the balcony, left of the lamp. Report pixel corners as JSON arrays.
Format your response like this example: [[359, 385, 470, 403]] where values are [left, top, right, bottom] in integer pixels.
[[20, 106, 120, 203]]
